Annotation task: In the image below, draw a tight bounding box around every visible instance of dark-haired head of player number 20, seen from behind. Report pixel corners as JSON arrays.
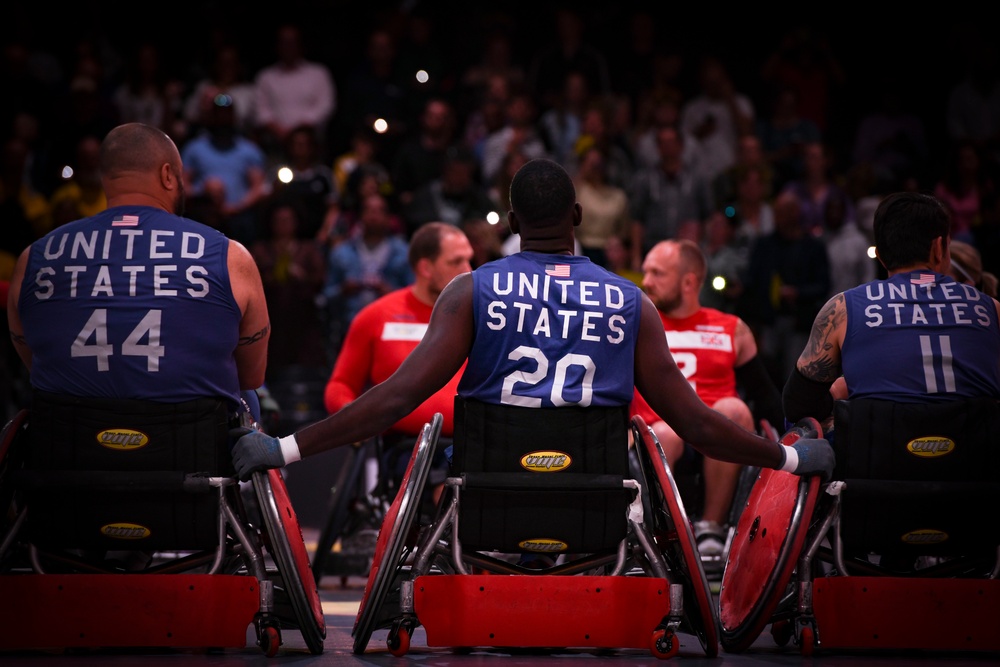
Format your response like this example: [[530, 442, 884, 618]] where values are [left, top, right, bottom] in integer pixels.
[[510, 158, 579, 247]]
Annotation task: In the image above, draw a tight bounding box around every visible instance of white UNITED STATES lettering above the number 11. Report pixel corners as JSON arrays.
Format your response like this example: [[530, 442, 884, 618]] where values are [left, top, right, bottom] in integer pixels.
[[865, 281, 991, 328]]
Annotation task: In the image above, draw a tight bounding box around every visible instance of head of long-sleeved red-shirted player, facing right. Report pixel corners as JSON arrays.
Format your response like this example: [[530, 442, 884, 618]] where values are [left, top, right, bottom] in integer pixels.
[[408, 222, 473, 300]]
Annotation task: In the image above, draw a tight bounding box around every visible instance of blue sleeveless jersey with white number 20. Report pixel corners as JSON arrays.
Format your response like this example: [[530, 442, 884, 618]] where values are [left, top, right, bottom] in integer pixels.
[[458, 252, 642, 408]]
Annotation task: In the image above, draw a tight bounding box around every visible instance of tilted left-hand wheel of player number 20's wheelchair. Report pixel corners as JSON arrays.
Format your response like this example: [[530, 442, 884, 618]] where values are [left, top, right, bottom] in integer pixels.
[[351, 413, 444, 654]]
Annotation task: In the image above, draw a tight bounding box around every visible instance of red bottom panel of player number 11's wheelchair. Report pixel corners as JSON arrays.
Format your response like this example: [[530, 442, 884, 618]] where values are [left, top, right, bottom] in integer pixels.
[[813, 576, 1000, 651]]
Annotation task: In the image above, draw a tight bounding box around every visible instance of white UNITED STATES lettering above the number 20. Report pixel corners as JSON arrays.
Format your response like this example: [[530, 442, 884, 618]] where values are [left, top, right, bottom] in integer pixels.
[[487, 271, 626, 344]]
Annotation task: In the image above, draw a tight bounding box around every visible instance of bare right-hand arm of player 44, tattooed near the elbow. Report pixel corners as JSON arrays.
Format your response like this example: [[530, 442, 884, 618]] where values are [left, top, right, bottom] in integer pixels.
[[227, 241, 271, 389]]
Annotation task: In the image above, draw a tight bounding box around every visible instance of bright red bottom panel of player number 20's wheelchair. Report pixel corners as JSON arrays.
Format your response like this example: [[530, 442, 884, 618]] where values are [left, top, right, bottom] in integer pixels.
[[413, 575, 670, 649]]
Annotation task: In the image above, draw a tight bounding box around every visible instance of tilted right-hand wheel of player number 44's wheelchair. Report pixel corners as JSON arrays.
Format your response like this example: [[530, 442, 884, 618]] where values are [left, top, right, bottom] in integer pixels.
[[253, 468, 326, 655]]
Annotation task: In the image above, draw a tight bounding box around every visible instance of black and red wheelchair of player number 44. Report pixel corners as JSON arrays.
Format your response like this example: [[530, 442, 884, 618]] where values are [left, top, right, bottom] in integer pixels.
[[0, 392, 326, 656]]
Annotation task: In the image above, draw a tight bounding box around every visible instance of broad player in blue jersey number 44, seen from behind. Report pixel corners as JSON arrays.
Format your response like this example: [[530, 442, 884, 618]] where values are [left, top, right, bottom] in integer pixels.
[[7, 123, 269, 411]]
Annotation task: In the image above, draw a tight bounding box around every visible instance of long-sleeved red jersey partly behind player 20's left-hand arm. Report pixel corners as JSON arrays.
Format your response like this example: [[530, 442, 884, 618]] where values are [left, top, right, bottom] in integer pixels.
[[323, 287, 465, 438]]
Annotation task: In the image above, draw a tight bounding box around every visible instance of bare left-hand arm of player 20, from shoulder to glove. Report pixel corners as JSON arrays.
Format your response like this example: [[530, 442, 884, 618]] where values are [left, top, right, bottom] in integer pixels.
[[295, 273, 474, 457]]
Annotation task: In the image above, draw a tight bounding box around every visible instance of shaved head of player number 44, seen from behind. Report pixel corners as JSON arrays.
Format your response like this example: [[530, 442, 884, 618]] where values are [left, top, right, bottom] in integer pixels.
[[101, 123, 184, 215]]
